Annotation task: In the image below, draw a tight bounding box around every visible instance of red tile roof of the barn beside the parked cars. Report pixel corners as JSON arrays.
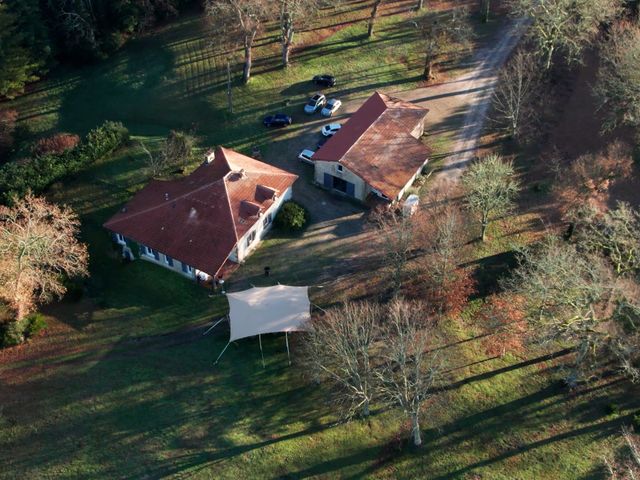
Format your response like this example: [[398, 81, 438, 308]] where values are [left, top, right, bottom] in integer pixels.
[[313, 92, 431, 199]]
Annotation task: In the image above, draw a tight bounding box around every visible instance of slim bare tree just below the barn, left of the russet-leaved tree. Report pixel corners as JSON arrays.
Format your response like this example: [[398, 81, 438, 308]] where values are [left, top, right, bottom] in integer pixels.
[[374, 212, 417, 296]]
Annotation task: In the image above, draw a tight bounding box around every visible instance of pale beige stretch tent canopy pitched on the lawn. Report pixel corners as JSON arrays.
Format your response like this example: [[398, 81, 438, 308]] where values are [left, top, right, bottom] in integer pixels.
[[227, 285, 311, 342]]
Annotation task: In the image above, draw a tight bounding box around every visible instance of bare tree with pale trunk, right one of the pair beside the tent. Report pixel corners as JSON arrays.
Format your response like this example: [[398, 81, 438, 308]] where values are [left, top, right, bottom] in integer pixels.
[[375, 300, 442, 446]]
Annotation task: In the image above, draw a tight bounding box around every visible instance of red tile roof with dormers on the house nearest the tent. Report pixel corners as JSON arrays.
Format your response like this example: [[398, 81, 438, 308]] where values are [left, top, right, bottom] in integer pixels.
[[104, 147, 298, 275]]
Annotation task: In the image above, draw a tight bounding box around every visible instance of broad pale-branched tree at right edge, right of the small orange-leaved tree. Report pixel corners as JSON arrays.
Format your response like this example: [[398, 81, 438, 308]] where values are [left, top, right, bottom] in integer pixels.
[[503, 237, 640, 384]]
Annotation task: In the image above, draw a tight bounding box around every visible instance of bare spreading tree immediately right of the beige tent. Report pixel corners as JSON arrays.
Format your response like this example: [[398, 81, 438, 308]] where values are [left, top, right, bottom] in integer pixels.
[[304, 302, 381, 417]]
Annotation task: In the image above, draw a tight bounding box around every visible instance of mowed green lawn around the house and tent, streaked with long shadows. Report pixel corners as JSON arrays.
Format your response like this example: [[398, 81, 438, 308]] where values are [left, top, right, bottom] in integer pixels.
[[0, 2, 640, 480]]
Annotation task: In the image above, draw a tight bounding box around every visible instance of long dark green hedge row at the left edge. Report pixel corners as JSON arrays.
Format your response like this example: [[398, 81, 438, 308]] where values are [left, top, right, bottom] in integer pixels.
[[0, 122, 129, 204]]
